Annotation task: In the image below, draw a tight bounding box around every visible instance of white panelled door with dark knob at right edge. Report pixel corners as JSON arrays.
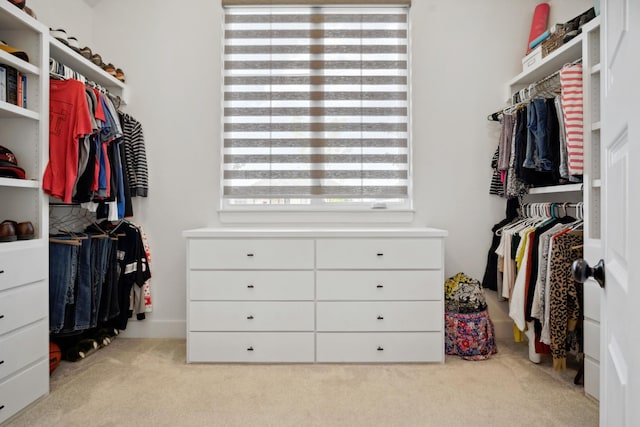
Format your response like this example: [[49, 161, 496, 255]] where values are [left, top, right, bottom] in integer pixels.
[[604, 0, 640, 427]]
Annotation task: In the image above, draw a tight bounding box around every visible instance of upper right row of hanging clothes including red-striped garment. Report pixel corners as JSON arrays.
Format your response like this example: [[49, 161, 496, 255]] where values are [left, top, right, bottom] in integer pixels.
[[490, 64, 583, 198]]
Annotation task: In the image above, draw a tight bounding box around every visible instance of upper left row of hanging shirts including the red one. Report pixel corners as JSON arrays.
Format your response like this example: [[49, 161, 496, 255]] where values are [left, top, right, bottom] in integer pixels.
[[43, 61, 148, 221]]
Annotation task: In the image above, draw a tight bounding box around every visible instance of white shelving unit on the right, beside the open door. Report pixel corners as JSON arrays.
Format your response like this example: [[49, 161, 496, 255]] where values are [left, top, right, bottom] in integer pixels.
[[507, 17, 602, 399]]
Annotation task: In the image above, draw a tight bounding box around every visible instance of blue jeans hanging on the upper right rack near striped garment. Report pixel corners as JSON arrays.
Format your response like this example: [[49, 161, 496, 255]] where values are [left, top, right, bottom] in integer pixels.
[[522, 98, 552, 171]]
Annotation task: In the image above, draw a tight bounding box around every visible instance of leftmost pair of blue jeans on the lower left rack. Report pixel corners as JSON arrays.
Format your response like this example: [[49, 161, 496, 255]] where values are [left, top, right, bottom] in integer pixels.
[[49, 241, 79, 333]]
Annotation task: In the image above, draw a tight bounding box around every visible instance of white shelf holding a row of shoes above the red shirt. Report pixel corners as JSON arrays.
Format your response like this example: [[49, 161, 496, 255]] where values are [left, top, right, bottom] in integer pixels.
[[49, 36, 128, 104]]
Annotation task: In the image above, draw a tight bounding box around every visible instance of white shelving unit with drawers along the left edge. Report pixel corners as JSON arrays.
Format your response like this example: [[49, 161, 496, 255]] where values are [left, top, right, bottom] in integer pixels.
[[0, 2, 49, 423]]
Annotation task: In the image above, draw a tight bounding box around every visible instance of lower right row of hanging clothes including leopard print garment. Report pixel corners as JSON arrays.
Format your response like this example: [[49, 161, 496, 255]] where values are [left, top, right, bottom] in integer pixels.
[[485, 203, 583, 369]]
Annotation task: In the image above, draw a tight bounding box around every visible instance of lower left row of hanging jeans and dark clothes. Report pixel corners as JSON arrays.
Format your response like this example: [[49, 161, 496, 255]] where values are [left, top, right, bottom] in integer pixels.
[[49, 220, 151, 335]]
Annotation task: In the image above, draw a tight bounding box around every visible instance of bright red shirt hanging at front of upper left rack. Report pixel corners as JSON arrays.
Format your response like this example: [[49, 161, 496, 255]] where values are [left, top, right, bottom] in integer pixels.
[[42, 80, 93, 203]]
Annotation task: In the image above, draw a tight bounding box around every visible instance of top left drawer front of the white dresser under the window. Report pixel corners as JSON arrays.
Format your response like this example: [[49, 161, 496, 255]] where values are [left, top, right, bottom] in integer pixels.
[[189, 239, 313, 270]]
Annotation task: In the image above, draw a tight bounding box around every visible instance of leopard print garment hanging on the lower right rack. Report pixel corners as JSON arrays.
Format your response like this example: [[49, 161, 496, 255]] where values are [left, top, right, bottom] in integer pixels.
[[549, 231, 583, 366]]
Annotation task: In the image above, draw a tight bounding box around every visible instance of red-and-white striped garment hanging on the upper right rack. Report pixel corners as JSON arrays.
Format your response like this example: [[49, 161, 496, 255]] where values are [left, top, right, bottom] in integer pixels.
[[560, 64, 584, 175]]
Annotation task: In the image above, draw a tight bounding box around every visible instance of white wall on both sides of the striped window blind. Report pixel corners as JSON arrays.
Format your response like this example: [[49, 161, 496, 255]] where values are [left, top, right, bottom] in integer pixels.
[[28, 0, 591, 336]]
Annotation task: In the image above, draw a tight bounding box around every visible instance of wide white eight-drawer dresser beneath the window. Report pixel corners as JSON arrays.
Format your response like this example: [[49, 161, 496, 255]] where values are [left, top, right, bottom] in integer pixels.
[[183, 228, 447, 363]]
